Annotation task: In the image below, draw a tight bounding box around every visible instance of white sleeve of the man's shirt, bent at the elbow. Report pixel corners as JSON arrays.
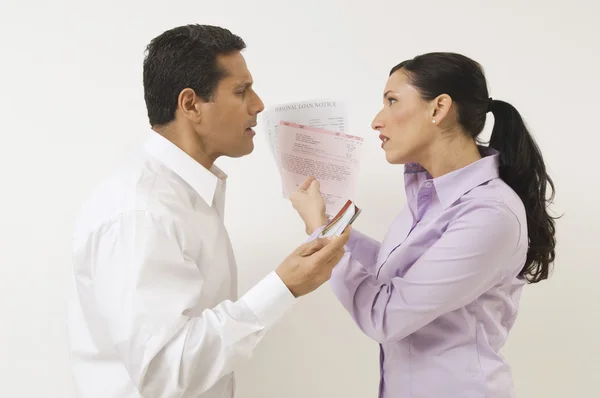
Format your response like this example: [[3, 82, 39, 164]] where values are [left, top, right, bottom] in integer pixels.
[[90, 212, 295, 398]]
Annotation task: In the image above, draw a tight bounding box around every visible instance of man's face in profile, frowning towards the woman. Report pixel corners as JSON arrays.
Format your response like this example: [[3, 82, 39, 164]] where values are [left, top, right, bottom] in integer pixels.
[[197, 52, 264, 160]]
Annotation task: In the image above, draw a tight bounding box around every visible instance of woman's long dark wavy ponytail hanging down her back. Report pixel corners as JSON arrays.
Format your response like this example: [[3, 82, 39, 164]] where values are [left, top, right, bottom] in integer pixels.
[[489, 100, 556, 283]]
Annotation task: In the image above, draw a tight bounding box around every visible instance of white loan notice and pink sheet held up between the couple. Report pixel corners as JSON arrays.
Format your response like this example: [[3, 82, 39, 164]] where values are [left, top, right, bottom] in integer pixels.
[[266, 101, 363, 218]]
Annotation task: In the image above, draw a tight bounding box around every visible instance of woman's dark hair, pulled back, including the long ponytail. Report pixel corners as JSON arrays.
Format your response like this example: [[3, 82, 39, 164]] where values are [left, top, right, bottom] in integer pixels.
[[390, 53, 556, 283]]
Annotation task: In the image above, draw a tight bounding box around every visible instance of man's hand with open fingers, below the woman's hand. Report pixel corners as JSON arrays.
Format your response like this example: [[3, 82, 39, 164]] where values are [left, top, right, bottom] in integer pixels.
[[275, 226, 351, 297]]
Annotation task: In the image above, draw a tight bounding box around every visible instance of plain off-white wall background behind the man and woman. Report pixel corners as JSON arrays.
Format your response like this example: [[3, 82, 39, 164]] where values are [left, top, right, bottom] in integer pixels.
[[0, 0, 600, 398]]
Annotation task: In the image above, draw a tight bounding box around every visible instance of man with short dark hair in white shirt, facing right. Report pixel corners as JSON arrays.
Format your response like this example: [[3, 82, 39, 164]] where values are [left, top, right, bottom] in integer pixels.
[[69, 25, 349, 398]]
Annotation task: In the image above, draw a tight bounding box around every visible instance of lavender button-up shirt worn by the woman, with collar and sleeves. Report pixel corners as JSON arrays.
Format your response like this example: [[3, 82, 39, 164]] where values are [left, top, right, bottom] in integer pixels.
[[315, 147, 528, 398]]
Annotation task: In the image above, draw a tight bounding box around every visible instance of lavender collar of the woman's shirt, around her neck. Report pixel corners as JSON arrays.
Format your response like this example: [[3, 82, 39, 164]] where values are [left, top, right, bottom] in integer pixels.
[[404, 146, 500, 209]]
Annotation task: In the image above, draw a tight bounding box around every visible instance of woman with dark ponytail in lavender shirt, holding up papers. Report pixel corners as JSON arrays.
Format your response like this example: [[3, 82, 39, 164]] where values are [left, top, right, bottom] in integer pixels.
[[291, 53, 555, 398]]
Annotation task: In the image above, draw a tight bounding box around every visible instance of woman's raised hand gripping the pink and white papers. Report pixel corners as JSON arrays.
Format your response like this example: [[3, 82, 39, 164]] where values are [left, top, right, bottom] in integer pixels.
[[290, 177, 329, 235]]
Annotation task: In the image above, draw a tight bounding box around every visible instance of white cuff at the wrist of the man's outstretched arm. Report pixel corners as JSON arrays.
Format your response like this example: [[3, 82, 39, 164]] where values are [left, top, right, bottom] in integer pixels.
[[242, 271, 297, 328]]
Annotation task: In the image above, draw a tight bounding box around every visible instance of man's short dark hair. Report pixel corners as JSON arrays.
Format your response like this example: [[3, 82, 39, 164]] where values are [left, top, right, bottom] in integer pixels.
[[144, 25, 246, 126]]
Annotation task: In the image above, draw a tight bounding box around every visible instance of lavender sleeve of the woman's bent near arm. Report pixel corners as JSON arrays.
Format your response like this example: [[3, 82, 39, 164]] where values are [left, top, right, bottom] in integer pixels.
[[330, 203, 526, 343]]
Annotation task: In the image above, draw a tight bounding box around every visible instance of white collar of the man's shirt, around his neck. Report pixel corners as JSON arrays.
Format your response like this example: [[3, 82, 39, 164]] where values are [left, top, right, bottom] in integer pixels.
[[144, 130, 227, 205]]
